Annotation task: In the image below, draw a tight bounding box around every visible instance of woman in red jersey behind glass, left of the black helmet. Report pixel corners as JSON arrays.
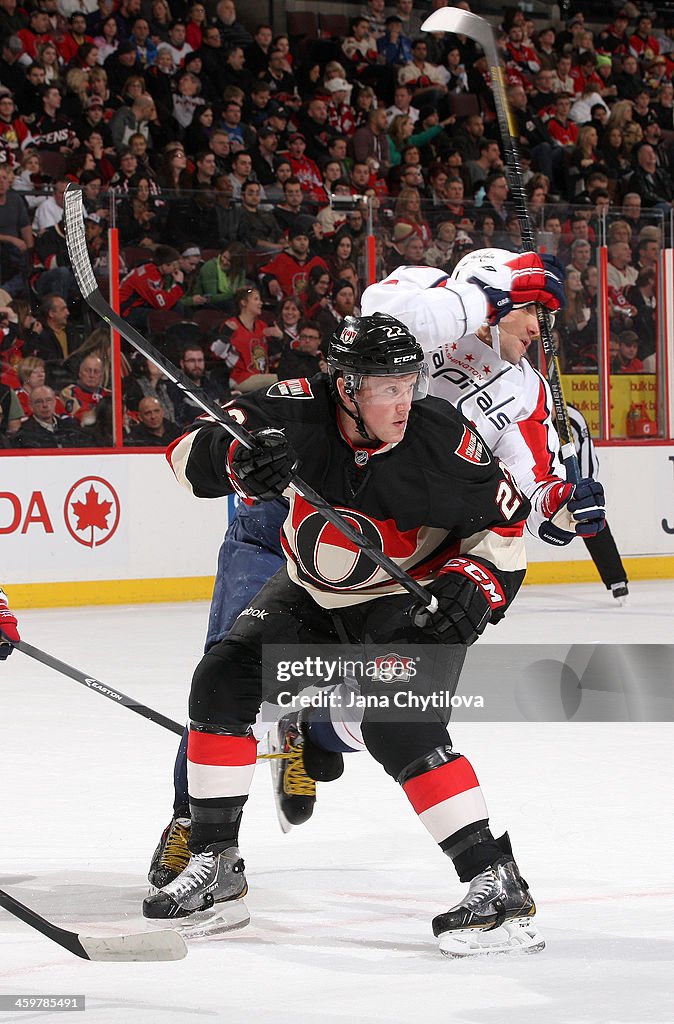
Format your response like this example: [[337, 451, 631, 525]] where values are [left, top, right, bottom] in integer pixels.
[[211, 288, 283, 394]]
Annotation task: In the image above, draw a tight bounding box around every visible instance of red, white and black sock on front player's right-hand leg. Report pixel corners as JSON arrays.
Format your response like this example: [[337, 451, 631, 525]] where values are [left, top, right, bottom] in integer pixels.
[[397, 745, 503, 882]]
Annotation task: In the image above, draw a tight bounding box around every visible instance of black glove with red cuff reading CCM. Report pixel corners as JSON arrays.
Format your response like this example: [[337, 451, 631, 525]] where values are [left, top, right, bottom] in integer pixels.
[[412, 558, 506, 646]]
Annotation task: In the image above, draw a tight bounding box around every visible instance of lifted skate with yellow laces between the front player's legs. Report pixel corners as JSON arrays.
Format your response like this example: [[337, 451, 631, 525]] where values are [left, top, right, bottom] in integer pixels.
[[269, 714, 315, 833]]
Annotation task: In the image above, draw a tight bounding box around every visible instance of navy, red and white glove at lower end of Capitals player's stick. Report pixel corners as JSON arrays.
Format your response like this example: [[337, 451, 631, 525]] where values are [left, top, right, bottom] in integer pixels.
[[539, 477, 606, 546]]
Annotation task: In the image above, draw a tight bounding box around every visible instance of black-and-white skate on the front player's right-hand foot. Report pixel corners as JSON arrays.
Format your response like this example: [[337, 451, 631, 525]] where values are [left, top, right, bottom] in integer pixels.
[[433, 835, 545, 957]]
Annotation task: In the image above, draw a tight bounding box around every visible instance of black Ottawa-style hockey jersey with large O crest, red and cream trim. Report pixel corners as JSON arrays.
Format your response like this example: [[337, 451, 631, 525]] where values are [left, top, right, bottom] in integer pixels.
[[167, 375, 530, 621]]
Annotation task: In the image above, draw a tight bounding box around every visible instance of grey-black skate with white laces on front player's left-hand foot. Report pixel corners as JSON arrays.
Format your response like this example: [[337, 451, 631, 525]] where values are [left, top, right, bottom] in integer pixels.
[[142, 844, 250, 934]]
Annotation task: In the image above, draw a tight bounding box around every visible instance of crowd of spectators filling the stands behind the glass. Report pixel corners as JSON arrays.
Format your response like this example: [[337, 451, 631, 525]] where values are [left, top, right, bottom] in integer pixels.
[[0, 0, 674, 447]]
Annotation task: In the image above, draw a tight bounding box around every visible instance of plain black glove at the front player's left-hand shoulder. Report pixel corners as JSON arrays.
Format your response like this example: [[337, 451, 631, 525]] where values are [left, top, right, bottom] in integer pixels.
[[226, 427, 299, 502]]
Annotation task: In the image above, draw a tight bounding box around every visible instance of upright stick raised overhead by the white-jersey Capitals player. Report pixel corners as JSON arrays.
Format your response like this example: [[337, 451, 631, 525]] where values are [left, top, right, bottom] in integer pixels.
[[421, 7, 581, 483]]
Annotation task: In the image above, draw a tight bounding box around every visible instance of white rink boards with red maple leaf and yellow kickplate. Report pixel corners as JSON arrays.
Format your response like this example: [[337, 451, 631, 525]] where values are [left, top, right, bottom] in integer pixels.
[[0, 442, 674, 607]]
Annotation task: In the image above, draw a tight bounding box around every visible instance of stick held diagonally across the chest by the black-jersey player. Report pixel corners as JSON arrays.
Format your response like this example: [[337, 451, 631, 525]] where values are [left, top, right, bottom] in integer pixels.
[[64, 184, 437, 613]]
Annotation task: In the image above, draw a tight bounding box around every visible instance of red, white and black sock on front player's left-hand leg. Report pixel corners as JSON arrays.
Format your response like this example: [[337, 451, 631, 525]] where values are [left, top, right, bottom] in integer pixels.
[[187, 729, 257, 853]]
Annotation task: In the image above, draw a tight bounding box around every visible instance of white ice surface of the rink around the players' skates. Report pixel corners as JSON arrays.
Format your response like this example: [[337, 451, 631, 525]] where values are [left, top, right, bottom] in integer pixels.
[[0, 582, 674, 1024]]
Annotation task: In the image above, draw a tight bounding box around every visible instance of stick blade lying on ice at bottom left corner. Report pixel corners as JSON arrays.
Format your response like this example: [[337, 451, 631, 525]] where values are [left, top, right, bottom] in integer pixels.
[[0, 889, 187, 963]]
